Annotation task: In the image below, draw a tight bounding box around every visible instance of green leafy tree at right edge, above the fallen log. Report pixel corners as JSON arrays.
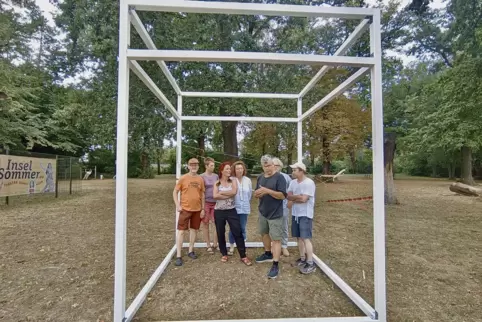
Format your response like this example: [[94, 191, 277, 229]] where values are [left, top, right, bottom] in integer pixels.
[[402, 59, 482, 185]]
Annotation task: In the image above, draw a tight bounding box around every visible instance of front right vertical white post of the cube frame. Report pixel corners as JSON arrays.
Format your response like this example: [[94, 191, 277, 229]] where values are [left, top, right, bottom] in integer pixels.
[[370, 10, 387, 322]]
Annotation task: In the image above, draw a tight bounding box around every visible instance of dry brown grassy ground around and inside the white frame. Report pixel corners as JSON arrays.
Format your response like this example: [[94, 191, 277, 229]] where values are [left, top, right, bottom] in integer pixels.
[[0, 176, 482, 321]]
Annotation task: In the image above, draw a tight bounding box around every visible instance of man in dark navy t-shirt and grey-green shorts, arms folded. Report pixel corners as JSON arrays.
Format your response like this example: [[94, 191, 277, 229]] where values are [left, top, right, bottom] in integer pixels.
[[254, 155, 286, 278]]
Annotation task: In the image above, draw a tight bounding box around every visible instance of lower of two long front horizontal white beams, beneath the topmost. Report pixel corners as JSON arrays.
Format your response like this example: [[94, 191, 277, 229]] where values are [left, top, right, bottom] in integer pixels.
[[127, 49, 374, 67]]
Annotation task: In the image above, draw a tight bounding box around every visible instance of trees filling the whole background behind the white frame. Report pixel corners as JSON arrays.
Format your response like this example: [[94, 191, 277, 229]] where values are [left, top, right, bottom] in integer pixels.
[[0, 0, 482, 184]]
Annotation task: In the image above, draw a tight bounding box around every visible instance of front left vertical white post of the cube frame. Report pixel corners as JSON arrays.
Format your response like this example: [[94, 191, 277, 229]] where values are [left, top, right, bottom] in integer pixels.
[[114, 0, 130, 322]]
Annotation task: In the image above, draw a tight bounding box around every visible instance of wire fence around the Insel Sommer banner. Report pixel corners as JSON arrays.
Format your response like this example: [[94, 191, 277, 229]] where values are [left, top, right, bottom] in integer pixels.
[[0, 148, 84, 205]]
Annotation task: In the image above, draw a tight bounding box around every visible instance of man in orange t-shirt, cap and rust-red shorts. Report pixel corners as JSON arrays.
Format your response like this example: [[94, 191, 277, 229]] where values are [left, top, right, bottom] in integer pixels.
[[172, 158, 206, 266]]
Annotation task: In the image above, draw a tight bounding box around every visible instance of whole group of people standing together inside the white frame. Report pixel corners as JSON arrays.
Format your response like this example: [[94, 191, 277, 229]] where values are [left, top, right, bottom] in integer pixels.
[[173, 155, 316, 278]]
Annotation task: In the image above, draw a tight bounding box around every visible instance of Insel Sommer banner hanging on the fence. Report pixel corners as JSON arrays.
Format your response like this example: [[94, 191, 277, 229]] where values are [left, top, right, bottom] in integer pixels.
[[0, 154, 57, 197]]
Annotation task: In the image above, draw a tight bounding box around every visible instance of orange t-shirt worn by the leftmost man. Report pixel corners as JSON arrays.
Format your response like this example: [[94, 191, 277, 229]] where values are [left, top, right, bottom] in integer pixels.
[[176, 174, 206, 211]]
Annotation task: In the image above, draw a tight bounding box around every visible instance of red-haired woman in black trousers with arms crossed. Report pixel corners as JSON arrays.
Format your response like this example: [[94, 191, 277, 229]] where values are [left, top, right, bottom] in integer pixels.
[[213, 162, 252, 266]]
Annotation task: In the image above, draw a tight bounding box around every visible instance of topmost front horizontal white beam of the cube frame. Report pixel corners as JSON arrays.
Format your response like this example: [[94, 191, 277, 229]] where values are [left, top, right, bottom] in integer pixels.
[[127, 0, 373, 19]]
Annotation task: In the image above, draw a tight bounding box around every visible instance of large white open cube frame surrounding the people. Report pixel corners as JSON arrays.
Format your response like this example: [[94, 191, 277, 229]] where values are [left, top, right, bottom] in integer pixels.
[[114, 0, 387, 322]]
